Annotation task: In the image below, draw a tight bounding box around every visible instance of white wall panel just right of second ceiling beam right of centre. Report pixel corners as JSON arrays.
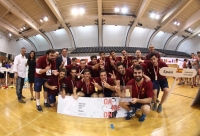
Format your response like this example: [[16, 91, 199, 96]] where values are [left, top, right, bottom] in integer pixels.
[[151, 31, 172, 49]]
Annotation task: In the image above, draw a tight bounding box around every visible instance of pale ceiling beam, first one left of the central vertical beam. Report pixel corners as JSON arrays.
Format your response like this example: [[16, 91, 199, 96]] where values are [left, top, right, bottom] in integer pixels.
[[45, 0, 76, 49]]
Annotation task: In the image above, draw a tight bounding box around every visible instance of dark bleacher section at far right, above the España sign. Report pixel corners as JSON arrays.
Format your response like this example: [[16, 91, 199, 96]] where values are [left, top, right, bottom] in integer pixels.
[[155, 49, 190, 57]]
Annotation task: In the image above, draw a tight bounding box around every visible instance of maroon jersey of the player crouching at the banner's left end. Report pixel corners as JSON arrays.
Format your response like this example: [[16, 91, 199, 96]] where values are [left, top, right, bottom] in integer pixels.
[[47, 75, 66, 95]]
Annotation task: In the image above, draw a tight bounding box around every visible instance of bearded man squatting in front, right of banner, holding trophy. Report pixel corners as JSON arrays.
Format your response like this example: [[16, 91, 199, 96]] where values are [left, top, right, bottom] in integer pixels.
[[116, 65, 153, 122]]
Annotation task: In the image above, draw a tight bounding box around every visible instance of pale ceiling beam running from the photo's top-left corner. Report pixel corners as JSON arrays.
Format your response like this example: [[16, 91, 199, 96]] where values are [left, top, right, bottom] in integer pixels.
[[0, 0, 52, 48]]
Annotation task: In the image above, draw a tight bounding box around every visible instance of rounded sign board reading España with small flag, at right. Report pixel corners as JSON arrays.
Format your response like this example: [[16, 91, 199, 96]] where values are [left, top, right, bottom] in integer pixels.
[[159, 67, 197, 78]]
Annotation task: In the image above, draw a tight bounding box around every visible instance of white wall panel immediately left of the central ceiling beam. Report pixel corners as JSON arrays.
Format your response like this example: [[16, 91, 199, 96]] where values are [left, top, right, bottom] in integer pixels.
[[70, 25, 98, 47]]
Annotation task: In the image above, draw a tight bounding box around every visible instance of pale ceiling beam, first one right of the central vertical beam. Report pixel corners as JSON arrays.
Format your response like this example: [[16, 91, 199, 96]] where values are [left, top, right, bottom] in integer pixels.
[[125, 0, 151, 47]]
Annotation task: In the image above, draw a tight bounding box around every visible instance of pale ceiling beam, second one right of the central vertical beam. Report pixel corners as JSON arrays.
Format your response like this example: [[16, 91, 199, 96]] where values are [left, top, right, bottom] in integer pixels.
[[147, 0, 193, 47]]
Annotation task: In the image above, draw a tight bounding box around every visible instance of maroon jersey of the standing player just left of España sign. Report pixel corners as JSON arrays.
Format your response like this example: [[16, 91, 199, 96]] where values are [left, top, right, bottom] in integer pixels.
[[144, 60, 168, 81]]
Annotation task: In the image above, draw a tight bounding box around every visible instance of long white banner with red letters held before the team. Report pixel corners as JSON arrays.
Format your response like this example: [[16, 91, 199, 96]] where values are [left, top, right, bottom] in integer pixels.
[[57, 95, 127, 118]]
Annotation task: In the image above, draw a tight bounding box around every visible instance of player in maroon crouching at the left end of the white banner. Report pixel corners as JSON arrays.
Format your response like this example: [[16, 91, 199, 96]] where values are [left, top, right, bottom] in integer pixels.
[[44, 68, 66, 107]]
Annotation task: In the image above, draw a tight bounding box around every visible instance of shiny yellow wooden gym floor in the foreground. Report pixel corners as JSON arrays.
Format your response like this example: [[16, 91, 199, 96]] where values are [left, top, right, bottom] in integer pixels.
[[0, 78, 200, 136]]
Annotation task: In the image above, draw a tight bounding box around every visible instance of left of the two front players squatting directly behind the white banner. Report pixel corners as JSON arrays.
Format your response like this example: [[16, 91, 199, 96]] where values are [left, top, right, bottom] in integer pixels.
[[73, 69, 99, 99]]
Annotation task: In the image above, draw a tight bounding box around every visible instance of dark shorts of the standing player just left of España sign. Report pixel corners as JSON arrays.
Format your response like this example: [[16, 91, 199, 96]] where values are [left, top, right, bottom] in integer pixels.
[[153, 78, 169, 91]]
